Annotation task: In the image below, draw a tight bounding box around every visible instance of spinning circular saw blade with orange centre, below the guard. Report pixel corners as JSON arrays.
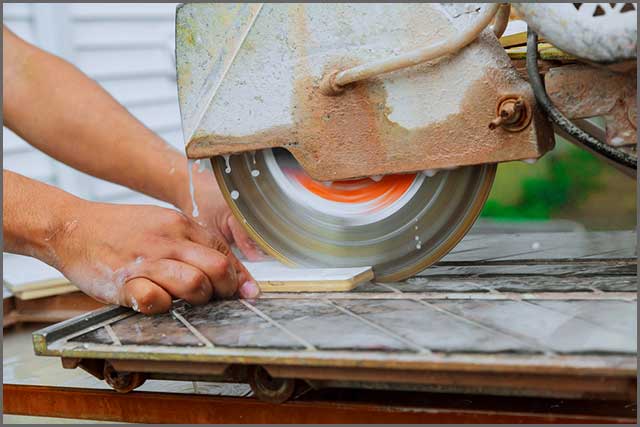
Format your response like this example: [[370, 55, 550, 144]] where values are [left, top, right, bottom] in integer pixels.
[[212, 149, 496, 281]]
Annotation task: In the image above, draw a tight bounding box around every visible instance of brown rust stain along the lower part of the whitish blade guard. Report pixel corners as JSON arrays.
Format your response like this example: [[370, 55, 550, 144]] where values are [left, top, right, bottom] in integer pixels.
[[182, 7, 553, 180]]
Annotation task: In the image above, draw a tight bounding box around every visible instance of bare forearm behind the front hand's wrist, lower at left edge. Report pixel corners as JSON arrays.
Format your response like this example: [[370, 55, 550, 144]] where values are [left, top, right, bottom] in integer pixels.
[[2, 170, 89, 267]]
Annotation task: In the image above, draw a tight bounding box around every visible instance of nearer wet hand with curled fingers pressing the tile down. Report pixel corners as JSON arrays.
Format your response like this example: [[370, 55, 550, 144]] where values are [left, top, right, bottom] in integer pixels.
[[49, 201, 259, 314]]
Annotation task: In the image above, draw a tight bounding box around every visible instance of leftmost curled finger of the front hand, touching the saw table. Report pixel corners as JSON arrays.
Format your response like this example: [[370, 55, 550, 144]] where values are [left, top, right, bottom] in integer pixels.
[[119, 277, 171, 314]]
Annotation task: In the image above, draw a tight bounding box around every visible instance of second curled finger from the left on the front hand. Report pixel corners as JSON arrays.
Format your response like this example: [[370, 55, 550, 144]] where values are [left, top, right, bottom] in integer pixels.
[[140, 259, 213, 305]]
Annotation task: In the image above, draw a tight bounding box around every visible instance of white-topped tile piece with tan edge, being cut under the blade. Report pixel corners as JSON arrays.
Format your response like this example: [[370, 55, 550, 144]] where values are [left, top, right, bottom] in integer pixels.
[[244, 261, 373, 292]]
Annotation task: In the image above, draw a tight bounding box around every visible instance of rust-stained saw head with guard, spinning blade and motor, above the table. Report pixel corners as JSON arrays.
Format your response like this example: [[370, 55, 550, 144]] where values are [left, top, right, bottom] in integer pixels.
[[176, 3, 637, 281]]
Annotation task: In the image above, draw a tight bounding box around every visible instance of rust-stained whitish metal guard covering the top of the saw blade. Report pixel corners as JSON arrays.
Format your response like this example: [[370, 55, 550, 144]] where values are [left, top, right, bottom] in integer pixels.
[[176, 4, 553, 180]]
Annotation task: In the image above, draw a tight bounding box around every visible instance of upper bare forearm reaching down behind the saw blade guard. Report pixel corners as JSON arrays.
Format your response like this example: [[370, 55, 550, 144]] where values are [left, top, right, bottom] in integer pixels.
[[3, 26, 188, 205]]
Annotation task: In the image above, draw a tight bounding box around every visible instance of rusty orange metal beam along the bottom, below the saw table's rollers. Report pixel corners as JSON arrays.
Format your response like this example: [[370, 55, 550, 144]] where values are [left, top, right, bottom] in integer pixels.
[[3, 384, 635, 424]]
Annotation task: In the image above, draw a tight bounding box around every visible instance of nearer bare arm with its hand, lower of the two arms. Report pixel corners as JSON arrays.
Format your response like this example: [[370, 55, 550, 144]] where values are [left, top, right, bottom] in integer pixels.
[[2, 171, 259, 313]]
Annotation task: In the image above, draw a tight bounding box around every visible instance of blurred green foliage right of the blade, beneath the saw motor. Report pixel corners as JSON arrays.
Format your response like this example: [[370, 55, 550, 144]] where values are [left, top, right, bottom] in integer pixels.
[[481, 138, 603, 221]]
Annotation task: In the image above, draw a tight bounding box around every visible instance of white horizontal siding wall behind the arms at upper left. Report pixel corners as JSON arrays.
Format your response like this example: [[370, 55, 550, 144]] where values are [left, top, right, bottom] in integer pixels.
[[2, 3, 183, 207]]
